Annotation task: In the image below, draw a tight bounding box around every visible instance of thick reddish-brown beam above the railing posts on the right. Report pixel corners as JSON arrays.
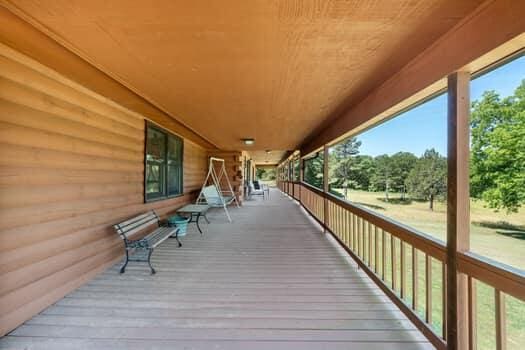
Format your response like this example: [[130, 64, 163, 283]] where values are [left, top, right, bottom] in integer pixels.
[[300, 0, 525, 154]]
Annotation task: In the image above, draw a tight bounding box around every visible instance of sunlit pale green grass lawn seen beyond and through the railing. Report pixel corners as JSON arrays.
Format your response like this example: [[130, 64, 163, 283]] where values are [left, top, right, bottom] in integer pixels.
[[332, 190, 525, 349]]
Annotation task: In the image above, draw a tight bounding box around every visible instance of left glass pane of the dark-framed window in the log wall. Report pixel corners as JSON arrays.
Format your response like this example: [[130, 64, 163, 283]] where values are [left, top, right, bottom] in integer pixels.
[[145, 128, 166, 199]]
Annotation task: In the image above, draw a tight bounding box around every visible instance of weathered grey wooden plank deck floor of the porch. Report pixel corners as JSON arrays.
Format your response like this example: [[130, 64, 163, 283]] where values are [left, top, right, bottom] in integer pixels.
[[0, 190, 432, 350]]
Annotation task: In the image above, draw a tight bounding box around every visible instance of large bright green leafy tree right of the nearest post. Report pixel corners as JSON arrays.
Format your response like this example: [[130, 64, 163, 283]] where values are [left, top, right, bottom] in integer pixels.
[[470, 80, 525, 212]]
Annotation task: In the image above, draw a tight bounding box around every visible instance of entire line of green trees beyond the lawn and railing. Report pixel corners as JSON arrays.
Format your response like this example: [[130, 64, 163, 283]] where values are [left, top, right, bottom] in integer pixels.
[[304, 80, 525, 212]]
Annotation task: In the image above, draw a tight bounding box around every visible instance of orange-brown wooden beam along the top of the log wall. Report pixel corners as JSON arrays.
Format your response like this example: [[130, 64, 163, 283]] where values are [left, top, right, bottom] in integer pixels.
[[0, 3, 217, 149]]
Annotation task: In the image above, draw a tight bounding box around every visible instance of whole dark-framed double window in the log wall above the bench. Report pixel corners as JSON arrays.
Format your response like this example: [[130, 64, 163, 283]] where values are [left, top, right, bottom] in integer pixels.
[[144, 124, 183, 201]]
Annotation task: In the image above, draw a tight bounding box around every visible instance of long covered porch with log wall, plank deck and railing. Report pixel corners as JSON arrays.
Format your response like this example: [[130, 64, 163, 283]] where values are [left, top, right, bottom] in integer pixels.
[[0, 0, 525, 350]]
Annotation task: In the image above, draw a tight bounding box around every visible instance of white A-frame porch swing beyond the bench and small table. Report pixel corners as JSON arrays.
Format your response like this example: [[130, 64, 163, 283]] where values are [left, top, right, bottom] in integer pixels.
[[196, 157, 239, 222]]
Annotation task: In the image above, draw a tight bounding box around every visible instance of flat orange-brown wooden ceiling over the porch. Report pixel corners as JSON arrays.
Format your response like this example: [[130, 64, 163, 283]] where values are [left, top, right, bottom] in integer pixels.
[[4, 0, 482, 150]]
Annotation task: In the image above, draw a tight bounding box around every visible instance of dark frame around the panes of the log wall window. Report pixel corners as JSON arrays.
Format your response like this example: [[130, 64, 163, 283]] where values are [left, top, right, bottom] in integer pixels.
[[143, 121, 184, 203]]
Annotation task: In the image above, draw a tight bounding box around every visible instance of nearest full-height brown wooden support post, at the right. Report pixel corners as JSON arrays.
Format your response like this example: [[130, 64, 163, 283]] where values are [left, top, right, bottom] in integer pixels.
[[446, 72, 470, 350]]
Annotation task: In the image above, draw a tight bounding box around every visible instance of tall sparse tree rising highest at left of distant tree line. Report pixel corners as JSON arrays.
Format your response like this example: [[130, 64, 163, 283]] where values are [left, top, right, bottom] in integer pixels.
[[331, 137, 361, 198]]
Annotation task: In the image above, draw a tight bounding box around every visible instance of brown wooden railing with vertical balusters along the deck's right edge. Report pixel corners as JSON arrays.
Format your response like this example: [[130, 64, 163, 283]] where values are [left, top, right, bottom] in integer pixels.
[[279, 181, 525, 350]]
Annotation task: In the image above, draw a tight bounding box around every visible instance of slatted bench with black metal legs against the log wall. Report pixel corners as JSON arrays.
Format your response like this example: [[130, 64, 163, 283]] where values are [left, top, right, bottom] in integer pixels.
[[113, 210, 181, 275]]
